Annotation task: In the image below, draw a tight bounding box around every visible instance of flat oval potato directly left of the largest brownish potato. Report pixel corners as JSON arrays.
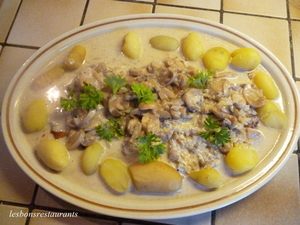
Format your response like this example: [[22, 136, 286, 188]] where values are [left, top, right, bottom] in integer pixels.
[[99, 158, 131, 193]]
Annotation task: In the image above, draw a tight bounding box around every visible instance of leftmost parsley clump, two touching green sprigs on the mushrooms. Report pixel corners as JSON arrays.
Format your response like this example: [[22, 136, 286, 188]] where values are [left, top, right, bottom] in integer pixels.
[[60, 84, 103, 110]]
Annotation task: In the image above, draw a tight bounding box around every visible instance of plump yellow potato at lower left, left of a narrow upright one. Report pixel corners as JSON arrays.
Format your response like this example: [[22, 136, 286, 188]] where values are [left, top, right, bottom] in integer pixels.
[[36, 140, 70, 171]]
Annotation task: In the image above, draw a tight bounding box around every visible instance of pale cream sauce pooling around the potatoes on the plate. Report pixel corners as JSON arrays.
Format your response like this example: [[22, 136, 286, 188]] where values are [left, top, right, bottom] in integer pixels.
[[20, 27, 279, 195]]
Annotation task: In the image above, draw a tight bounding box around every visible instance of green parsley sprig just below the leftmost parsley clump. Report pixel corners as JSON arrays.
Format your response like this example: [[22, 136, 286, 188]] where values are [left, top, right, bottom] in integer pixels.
[[95, 119, 124, 142]]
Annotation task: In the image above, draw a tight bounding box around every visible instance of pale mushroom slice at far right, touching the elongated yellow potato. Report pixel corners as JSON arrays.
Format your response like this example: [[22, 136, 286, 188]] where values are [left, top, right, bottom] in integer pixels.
[[243, 85, 266, 108]]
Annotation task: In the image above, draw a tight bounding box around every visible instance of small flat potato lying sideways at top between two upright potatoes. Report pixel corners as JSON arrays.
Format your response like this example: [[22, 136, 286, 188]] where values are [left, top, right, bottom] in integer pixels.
[[150, 35, 179, 51]]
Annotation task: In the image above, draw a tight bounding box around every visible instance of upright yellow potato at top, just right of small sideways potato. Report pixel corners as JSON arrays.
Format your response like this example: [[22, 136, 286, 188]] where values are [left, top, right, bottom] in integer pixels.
[[181, 32, 204, 61]]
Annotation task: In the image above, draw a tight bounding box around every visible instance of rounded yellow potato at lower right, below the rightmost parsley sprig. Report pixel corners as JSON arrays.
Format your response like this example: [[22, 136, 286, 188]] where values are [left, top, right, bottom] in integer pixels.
[[225, 143, 258, 173]]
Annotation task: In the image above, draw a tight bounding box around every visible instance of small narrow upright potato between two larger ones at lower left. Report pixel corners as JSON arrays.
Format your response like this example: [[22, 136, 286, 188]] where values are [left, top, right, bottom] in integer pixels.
[[81, 142, 103, 175]]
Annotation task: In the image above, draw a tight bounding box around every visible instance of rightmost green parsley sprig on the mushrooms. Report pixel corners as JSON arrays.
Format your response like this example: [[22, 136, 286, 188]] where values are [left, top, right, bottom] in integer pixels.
[[200, 115, 231, 146]]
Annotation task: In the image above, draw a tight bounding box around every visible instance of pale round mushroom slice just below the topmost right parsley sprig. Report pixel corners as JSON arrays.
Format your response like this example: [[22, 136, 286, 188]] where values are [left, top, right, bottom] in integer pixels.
[[182, 88, 204, 112]]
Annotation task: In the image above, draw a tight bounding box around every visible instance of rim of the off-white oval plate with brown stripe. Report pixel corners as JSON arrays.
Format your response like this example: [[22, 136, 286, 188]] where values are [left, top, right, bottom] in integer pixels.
[[2, 14, 300, 219]]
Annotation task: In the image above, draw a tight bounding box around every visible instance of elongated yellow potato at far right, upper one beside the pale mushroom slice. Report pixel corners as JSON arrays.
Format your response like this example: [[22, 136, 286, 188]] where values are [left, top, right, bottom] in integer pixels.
[[253, 72, 279, 99]]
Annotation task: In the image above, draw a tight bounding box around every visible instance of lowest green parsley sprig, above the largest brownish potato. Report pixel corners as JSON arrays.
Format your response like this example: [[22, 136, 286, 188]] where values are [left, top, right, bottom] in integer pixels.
[[137, 131, 166, 163]]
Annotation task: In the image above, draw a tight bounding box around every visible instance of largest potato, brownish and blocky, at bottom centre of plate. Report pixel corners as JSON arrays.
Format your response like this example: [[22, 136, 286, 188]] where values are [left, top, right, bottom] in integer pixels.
[[128, 161, 182, 193]]
